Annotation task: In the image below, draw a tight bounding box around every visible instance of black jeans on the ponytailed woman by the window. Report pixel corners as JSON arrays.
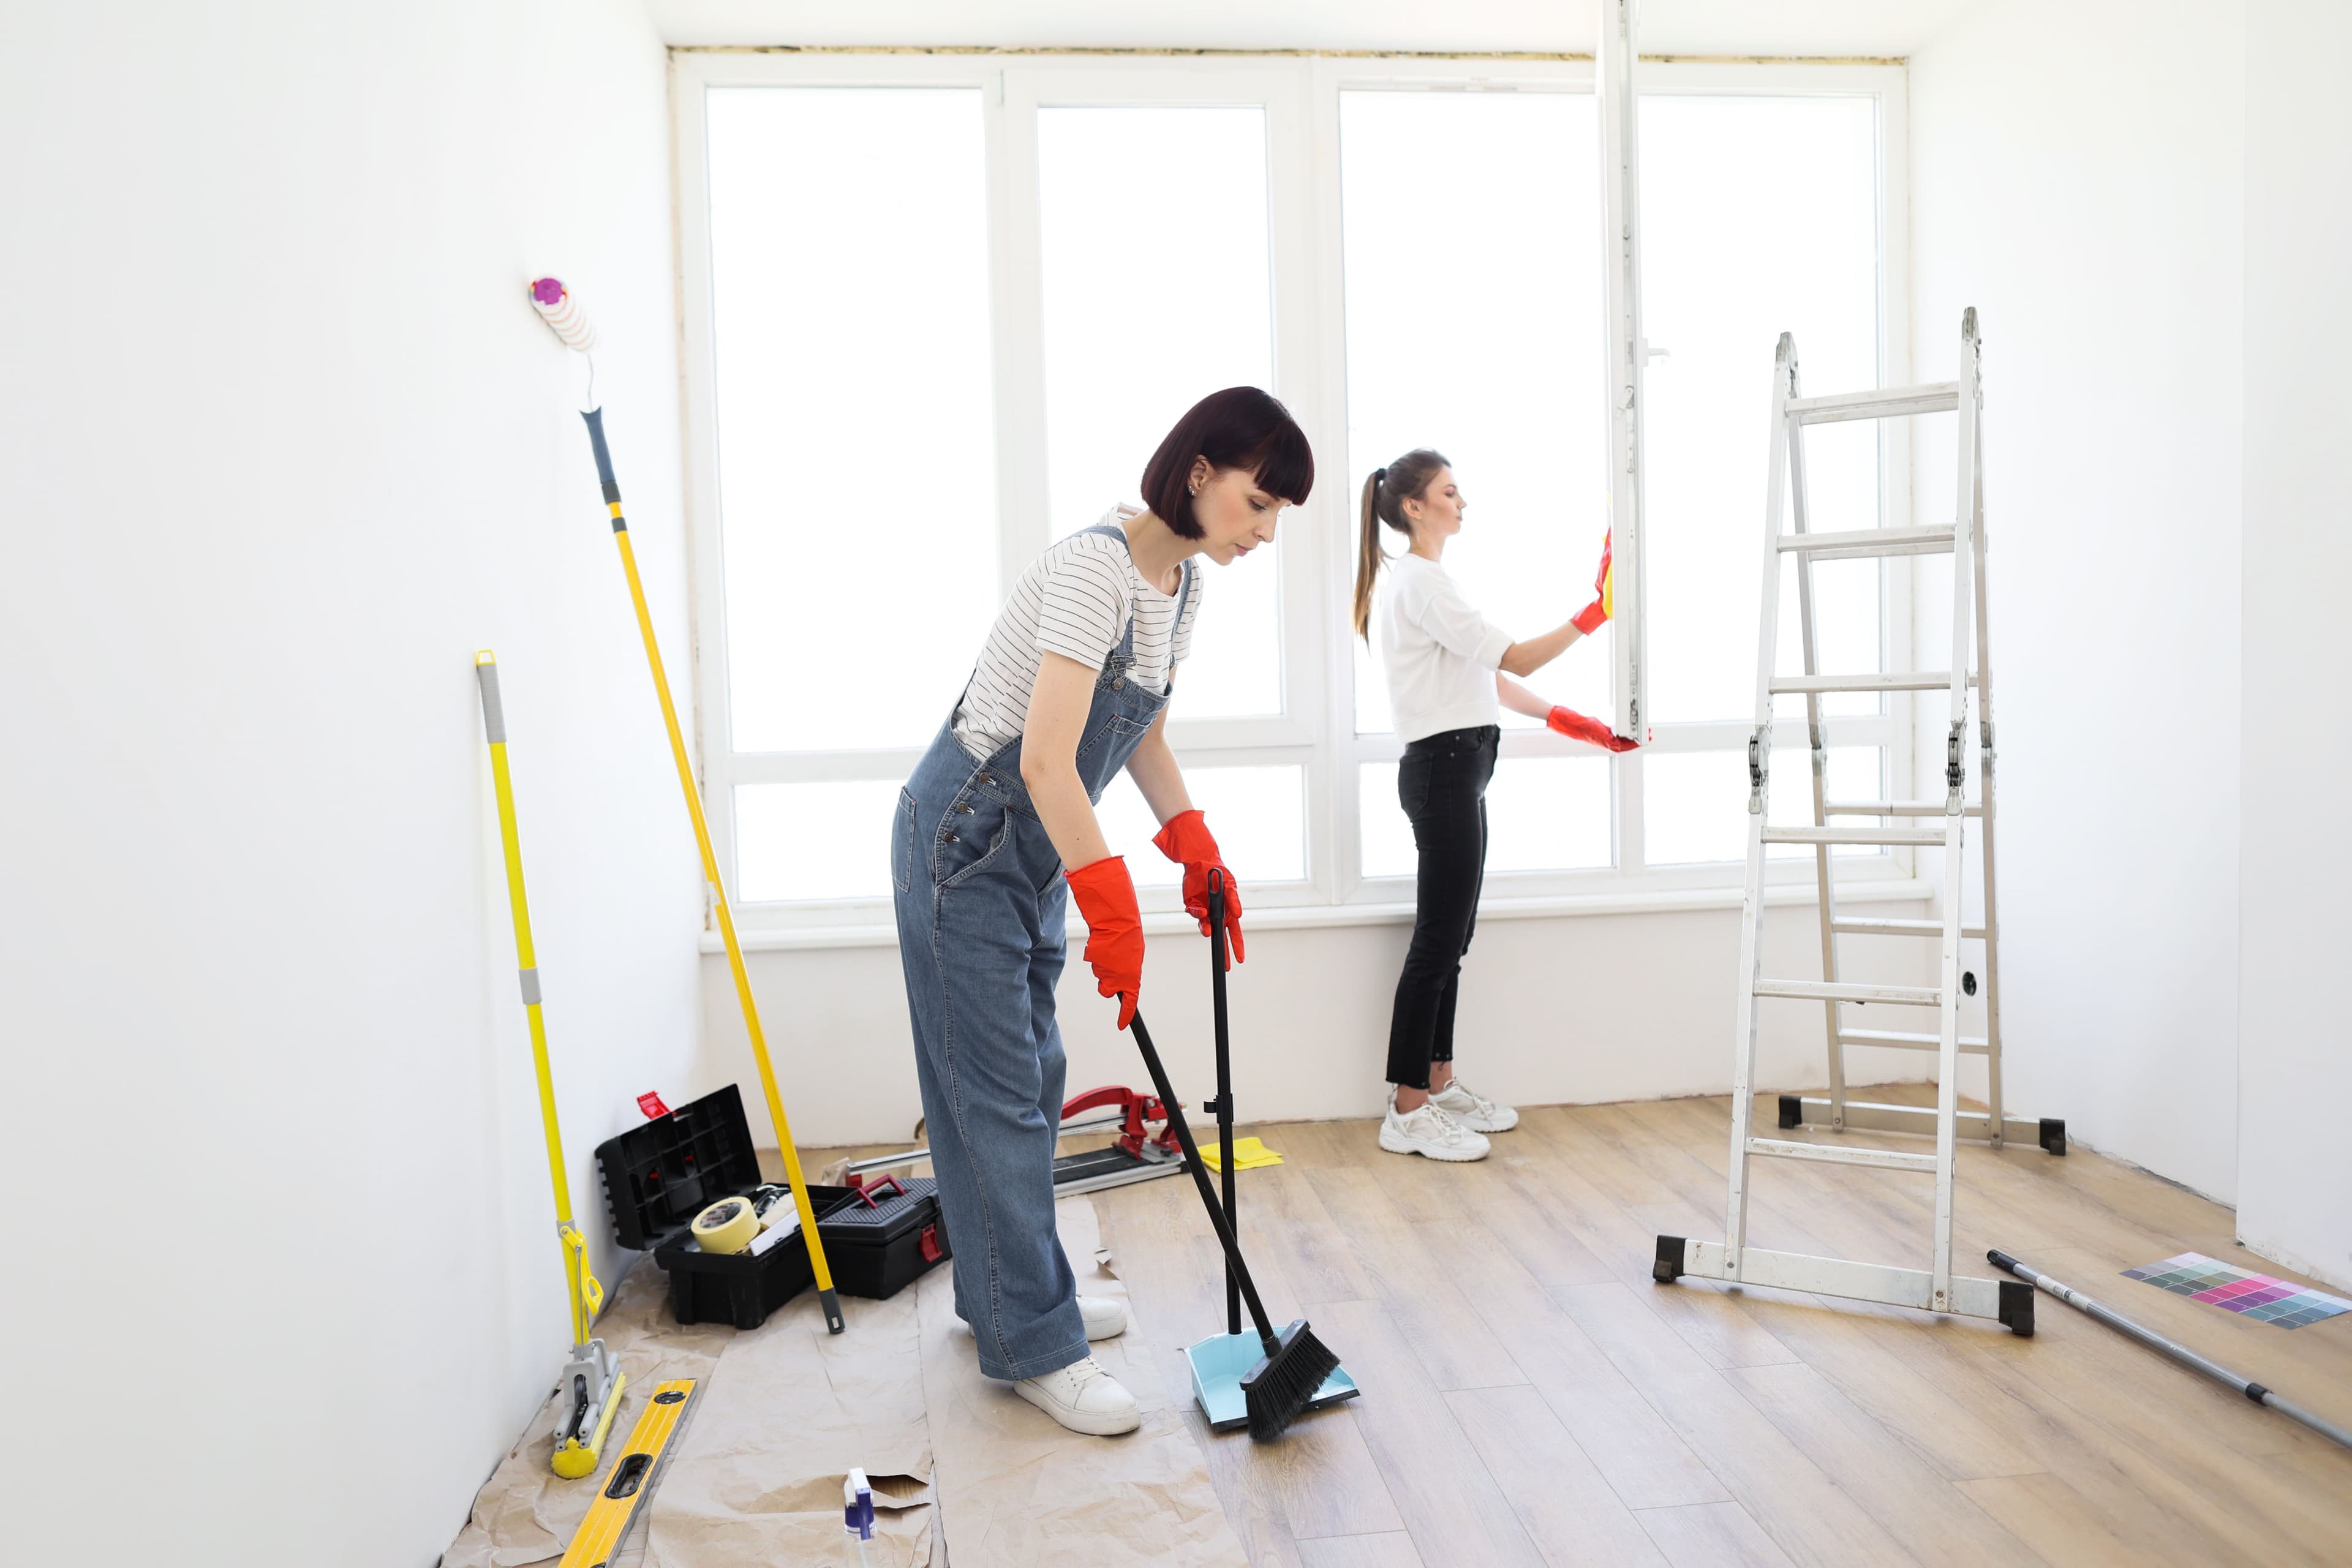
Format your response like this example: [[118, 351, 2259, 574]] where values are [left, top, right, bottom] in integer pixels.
[[1388, 724, 1503, 1088]]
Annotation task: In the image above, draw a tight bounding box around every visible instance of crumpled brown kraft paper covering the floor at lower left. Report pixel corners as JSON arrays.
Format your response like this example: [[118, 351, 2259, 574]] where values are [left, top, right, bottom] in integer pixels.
[[442, 1197, 1249, 1568]]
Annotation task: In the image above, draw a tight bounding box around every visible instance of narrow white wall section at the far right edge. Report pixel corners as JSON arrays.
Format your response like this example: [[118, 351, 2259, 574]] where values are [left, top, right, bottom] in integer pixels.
[[2237, 0, 2352, 1286]]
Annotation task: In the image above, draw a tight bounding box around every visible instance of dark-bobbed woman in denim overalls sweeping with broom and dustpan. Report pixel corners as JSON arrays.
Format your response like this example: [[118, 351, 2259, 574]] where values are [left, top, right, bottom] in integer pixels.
[[891, 385, 1315, 1434]]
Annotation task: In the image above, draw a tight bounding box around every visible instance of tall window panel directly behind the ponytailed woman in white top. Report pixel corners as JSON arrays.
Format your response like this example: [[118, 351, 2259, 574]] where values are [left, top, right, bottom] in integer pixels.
[[1338, 82, 1613, 895]]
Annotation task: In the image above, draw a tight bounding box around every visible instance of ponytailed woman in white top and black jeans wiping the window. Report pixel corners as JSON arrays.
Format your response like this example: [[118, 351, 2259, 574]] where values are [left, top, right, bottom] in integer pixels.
[[1355, 449, 1632, 1159]]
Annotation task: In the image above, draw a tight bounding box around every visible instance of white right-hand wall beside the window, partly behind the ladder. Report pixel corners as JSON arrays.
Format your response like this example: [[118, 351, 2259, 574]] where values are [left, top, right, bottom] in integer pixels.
[[1910, 0, 2251, 1199]]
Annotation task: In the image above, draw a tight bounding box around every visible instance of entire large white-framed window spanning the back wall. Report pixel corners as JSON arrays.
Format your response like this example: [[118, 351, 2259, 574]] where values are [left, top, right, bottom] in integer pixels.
[[677, 51, 1910, 929]]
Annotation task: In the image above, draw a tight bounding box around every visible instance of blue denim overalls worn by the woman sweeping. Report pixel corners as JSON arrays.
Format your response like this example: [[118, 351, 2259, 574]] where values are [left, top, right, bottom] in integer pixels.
[[891, 524, 1193, 1380]]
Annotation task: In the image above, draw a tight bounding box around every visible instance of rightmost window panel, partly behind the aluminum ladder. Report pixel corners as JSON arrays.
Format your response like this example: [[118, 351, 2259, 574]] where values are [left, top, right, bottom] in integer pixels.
[[1639, 92, 1893, 865]]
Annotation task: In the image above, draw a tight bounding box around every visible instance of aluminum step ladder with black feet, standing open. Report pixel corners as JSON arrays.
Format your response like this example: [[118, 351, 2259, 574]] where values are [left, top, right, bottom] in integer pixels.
[[1651, 308, 2065, 1335]]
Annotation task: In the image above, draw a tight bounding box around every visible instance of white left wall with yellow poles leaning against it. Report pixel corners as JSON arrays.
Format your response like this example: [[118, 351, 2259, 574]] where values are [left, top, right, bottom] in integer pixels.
[[0, 0, 698, 1568]]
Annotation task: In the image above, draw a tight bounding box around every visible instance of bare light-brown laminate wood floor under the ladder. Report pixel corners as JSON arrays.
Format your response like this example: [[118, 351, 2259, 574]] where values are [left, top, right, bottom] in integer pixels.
[[812, 1086, 2352, 1568]]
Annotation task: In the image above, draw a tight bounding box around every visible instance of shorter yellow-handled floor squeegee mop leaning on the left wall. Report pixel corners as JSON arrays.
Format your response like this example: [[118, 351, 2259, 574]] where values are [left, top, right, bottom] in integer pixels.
[[473, 649, 628, 1481]]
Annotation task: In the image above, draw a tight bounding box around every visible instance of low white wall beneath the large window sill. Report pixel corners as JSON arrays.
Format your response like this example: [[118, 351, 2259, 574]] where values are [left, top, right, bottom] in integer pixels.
[[692, 893, 1929, 1145]]
